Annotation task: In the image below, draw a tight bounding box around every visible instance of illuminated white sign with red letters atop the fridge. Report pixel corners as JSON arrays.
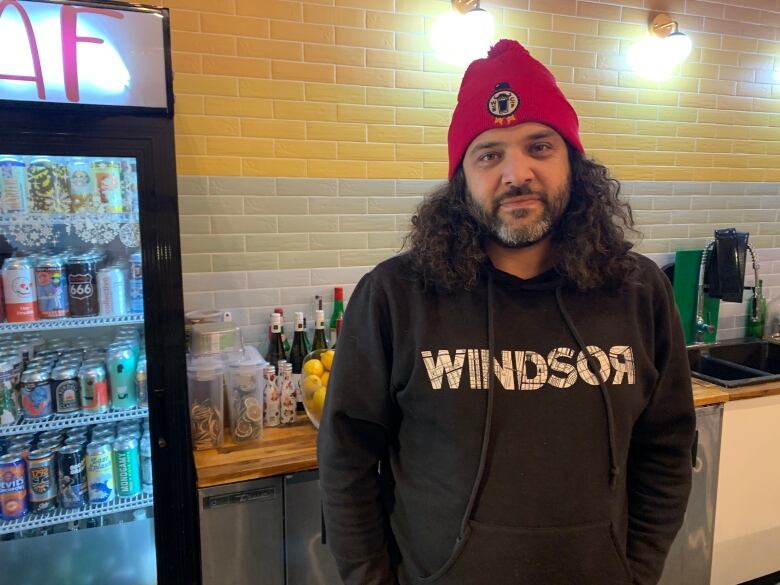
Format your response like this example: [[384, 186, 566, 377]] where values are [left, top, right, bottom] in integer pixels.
[[0, 0, 168, 108]]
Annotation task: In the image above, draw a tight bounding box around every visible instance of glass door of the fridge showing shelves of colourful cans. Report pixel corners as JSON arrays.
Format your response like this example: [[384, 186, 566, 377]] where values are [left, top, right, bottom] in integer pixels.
[[0, 152, 157, 585]]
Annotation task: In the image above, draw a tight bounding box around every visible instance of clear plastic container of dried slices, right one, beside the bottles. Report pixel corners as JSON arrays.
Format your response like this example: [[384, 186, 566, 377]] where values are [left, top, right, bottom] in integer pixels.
[[228, 359, 263, 443]]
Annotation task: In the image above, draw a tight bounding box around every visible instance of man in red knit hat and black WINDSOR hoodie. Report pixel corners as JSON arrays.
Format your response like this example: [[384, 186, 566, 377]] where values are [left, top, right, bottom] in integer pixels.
[[319, 40, 695, 585]]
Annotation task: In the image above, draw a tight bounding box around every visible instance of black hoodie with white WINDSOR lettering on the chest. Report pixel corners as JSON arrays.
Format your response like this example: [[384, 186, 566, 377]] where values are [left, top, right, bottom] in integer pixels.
[[318, 255, 695, 585]]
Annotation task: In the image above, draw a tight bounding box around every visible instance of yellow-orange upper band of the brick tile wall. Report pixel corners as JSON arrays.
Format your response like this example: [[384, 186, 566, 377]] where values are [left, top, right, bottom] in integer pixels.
[[166, 0, 780, 180]]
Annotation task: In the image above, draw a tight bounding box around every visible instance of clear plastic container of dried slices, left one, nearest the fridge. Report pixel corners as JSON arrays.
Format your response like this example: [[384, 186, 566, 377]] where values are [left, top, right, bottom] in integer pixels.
[[187, 356, 225, 451]]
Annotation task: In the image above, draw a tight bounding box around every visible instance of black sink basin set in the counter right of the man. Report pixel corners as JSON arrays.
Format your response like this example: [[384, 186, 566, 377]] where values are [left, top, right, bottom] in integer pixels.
[[688, 339, 780, 388]]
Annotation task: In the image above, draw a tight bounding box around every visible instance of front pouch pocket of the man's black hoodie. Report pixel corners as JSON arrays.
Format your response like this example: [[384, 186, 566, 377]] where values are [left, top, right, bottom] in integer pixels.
[[417, 521, 631, 585]]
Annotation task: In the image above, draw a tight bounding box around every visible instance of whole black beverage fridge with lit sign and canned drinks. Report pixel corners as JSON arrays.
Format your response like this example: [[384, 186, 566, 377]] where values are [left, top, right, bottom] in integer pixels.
[[0, 0, 200, 585]]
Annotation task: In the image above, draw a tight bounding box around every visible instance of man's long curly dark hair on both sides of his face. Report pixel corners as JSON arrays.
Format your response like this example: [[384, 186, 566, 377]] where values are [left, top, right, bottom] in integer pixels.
[[404, 145, 639, 291]]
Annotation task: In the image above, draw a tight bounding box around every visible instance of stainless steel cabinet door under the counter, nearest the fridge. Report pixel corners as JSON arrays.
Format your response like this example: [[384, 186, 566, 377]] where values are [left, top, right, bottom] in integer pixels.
[[199, 477, 284, 585]]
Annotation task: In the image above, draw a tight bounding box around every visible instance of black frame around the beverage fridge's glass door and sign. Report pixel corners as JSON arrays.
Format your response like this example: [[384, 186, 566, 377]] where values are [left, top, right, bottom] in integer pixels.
[[0, 0, 201, 585]]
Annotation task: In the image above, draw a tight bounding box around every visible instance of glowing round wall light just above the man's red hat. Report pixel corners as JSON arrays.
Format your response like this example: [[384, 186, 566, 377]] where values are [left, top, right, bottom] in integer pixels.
[[431, 0, 495, 66]]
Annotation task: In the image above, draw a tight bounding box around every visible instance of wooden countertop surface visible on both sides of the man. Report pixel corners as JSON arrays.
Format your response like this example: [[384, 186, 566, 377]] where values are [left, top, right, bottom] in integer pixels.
[[193, 378, 780, 488]]
